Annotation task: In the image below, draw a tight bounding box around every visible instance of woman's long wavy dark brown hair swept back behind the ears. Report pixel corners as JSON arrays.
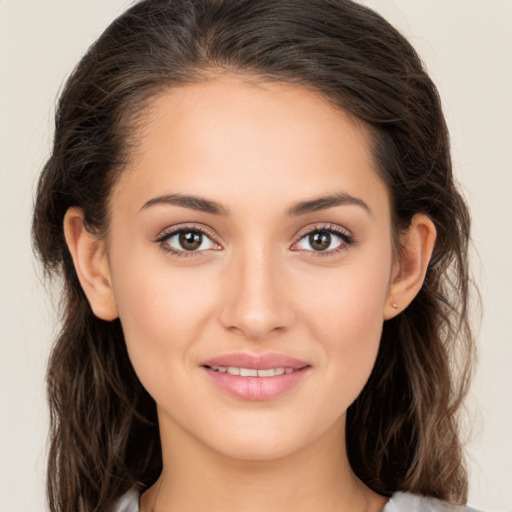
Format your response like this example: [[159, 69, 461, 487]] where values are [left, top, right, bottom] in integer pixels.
[[33, 0, 473, 512]]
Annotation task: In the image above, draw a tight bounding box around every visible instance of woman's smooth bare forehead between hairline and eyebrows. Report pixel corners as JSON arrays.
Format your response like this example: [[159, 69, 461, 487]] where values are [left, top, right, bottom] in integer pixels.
[[113, 76, 386, 218]]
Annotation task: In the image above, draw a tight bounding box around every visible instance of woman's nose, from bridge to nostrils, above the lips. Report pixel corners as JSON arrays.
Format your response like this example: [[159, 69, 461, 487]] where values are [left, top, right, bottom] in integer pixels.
[[220, 250, 294, 341]]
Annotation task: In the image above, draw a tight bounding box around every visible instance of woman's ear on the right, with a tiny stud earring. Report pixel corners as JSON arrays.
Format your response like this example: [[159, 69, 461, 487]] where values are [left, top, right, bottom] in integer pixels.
[[384, 214, 436, 320]]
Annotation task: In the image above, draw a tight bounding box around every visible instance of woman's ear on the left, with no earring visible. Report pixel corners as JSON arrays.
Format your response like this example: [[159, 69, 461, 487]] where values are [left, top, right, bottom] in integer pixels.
[[64, 207, 118, 321]]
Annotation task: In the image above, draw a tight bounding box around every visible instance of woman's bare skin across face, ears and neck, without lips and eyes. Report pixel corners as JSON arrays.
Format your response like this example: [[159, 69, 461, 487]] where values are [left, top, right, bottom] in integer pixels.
[[65, 76, 435, 512]]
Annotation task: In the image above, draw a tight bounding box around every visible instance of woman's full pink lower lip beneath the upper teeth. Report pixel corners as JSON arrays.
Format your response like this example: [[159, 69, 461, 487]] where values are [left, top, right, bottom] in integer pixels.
[[203, 366, 311, 400]]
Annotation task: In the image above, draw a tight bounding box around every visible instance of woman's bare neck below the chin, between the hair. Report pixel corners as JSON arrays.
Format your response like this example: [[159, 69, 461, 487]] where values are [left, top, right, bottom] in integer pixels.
[[141, 418, 386, 512]]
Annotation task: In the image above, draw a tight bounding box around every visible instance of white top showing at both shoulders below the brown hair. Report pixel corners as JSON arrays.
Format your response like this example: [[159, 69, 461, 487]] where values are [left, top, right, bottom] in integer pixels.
[[114, 489, 478, 512]]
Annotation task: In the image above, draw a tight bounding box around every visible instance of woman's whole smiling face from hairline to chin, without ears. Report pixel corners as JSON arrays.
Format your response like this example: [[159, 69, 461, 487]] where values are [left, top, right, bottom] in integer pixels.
[[108, 76, 393, 459]]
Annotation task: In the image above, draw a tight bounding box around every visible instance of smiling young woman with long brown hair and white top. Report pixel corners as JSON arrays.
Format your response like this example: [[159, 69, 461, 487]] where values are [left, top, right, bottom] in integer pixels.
[[33, 0, 473, 512]]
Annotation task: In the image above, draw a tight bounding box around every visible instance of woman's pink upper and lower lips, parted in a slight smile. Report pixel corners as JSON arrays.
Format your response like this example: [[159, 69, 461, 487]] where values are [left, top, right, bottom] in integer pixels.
[[201, 353, 311, 401]]
